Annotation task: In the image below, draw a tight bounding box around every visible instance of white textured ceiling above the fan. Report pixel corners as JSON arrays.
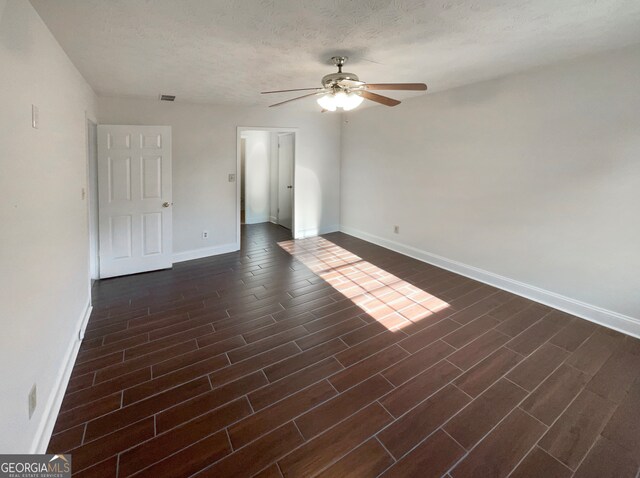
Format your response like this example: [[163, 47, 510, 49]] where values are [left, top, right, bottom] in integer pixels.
[[31, 0, 640, 107]]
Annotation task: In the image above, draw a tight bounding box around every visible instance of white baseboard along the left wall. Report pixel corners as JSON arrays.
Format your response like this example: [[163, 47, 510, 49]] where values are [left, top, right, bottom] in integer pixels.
[[29, 300, 93, 453]]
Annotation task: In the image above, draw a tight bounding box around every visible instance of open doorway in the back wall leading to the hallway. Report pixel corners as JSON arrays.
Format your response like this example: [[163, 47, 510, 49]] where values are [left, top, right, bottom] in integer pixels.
[[237, 127, 297, 243]]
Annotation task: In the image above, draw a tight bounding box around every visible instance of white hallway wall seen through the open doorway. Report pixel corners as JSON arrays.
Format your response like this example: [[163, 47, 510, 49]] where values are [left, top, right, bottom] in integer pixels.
[[242, 131, 271, 224]]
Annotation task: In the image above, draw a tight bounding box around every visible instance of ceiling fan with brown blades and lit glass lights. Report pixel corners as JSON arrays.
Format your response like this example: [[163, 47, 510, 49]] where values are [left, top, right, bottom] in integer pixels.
[[262, 56, 427, 112]]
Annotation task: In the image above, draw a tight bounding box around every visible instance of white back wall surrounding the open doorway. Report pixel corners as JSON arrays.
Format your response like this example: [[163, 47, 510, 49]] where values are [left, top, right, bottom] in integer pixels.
[[98, 98, 340, 257]]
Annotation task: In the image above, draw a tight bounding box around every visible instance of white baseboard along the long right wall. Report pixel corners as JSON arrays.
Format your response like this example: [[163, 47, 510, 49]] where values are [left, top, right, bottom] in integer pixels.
[[340, 226, 640, 338]]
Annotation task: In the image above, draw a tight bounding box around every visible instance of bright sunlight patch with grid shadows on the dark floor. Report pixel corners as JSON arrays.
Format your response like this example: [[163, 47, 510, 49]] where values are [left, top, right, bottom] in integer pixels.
[[278, 237, 449, 330]]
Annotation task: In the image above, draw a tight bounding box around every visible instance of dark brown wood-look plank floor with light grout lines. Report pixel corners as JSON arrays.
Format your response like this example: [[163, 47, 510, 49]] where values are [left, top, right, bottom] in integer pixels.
[[49, 224, 640, 478]]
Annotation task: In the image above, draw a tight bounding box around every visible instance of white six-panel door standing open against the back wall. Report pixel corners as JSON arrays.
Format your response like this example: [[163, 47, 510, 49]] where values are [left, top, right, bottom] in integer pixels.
[[98, 125, 172, 278]]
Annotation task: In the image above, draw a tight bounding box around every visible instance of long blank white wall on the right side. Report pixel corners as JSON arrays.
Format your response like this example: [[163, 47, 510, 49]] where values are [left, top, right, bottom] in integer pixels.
[[342, 46, 640, 334]]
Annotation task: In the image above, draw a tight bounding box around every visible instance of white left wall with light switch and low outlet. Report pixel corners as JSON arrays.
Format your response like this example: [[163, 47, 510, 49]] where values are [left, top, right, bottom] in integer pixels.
[[0, 0, 95, 453]]
